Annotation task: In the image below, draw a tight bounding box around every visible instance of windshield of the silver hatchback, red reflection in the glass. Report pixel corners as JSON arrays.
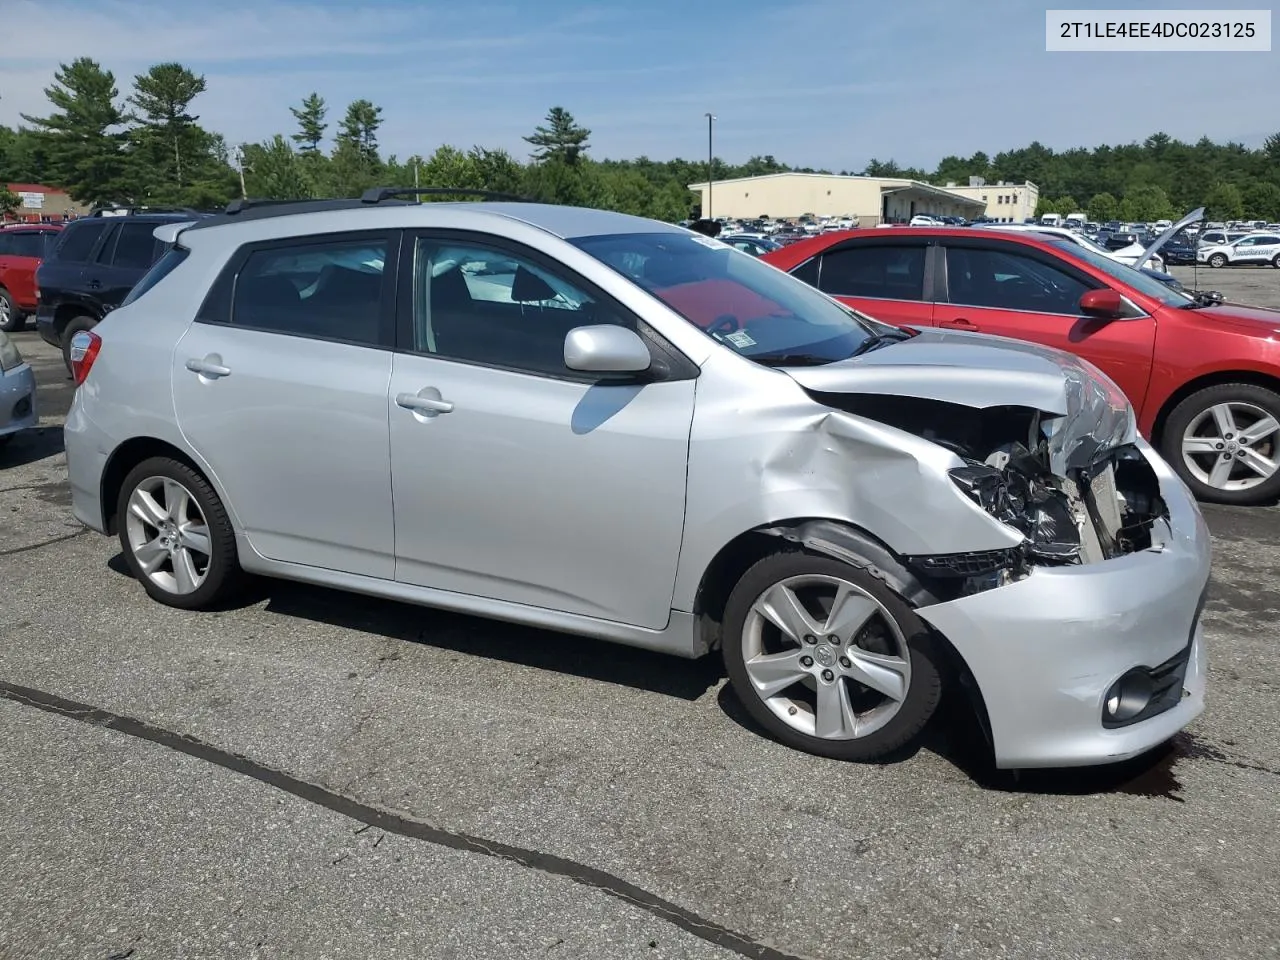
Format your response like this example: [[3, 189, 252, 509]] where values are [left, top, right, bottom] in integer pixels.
[[573, 233, 893, 362]]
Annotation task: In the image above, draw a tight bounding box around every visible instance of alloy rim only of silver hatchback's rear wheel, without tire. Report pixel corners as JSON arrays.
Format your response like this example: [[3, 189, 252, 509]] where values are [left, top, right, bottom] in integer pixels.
[[125, 476, 211, 595]]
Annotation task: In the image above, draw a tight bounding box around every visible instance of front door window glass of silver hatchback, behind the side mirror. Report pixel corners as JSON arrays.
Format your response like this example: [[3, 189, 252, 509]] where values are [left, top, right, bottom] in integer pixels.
[[413, 238, 635, 378]]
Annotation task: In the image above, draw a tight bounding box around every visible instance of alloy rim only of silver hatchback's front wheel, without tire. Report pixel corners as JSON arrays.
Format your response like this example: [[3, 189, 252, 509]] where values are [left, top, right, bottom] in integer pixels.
[[742, 573, 911, 740]]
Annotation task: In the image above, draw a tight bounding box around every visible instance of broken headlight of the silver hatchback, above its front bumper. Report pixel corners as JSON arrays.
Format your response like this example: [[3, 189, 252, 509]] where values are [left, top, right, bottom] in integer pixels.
[[950, 458, 1080, 563]]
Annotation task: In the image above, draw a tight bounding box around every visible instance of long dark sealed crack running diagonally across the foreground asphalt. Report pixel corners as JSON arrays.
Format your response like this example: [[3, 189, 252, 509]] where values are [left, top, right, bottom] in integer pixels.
[[0, 680, 806, 960]]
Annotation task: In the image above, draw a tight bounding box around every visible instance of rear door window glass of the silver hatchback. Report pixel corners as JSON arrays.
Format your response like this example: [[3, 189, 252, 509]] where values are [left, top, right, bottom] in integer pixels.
[[230, 239, 387, 346]]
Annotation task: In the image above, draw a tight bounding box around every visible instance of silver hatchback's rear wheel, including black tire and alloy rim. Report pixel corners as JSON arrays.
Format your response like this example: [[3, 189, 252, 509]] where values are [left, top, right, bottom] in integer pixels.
[[115, 457, 243, 609]]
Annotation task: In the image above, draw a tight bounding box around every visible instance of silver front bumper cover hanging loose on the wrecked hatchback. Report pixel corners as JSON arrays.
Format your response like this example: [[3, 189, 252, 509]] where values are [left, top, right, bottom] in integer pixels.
[[919, 443, 1210, 768]]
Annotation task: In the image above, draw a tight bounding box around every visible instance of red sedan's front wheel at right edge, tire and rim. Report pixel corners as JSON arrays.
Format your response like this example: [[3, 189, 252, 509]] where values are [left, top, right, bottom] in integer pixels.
[[1160, 383, 1280, 506]]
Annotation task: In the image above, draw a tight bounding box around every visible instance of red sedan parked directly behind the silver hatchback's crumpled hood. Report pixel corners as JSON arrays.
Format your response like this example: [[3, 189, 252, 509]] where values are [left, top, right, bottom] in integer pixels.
[[762, 227, 1280, 504]]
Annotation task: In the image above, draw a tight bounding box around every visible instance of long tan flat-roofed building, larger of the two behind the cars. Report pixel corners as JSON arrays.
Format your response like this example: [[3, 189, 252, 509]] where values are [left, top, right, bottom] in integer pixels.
[[689, 173, 986, 227]]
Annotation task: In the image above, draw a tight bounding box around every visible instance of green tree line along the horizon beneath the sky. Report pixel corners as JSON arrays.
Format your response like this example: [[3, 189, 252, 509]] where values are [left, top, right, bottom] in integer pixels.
[[0, 58, 1280, 220]]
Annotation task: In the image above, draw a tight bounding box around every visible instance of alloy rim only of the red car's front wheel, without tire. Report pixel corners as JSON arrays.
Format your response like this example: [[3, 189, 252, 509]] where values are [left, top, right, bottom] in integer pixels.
[[1183, 401, 1280, 490]]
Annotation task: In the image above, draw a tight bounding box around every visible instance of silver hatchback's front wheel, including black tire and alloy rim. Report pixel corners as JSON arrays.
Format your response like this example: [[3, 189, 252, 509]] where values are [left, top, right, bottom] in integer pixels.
[[722, 553, 942, 762]]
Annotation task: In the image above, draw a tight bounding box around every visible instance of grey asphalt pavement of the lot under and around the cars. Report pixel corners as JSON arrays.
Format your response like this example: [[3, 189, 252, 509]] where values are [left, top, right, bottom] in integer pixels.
[[0, 269, 1280, 960]]
